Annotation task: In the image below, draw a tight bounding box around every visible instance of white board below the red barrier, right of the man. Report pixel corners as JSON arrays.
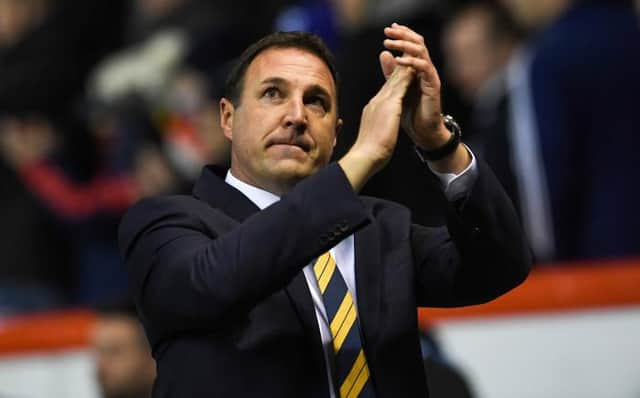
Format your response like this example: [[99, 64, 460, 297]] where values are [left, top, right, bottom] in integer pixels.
[[435, 307, 640, 398]]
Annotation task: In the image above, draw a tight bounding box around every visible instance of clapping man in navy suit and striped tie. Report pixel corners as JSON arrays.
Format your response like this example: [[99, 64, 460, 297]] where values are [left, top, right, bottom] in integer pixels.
[[120, 24, 529, 397]]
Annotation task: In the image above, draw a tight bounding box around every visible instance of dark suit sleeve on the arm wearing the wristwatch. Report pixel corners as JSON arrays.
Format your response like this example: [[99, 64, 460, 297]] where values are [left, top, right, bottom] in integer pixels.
[[411, 160, 531, 307]]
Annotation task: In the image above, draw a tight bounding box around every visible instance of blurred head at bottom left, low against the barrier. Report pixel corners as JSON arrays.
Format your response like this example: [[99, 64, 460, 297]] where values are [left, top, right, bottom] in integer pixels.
[[92, 300, 156, 398]]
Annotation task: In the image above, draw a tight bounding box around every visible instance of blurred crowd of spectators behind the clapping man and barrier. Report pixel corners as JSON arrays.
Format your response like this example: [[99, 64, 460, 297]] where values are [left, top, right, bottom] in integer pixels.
[[0, 0, 640, 316]]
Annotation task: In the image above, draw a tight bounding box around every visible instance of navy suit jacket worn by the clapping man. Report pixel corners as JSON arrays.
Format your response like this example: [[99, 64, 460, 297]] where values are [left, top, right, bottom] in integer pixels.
[[120, 163, 530, 398]]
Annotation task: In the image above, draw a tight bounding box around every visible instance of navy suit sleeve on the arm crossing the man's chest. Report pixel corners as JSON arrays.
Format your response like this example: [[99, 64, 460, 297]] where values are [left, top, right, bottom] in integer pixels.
[[119, 164, 367, 337]]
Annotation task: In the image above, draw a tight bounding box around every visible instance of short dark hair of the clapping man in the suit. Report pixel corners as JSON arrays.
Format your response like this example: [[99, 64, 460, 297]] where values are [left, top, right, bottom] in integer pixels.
[[224, 31, 338, 106]]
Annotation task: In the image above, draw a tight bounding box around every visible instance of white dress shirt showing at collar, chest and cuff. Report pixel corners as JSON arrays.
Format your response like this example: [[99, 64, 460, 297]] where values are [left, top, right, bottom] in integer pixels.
[[225, 151, 478, 398]]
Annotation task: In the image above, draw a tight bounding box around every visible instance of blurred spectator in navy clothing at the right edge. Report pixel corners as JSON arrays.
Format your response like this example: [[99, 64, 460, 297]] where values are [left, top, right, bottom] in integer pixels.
[[530, 0, 640, 260]]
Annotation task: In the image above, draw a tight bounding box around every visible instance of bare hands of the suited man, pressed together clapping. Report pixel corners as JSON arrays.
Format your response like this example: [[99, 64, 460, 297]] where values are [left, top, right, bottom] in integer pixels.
[[339, 23, 471, 190]]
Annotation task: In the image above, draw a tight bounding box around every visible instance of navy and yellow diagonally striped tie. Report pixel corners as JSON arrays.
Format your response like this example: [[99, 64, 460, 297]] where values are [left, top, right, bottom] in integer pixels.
[[313, 252, 375, 398]]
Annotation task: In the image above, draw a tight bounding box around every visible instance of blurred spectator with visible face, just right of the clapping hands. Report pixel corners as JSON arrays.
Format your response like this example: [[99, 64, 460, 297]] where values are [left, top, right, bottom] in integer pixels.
[[442, 0, 553, 261]]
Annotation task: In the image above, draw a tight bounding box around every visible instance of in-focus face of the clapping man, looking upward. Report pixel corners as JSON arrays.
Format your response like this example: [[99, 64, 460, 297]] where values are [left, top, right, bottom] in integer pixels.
[[220, 48, 342, 194]]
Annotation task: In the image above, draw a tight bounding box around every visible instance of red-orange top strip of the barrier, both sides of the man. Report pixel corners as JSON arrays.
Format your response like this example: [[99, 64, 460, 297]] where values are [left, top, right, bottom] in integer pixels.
[[0, 259, 640, 355]]
